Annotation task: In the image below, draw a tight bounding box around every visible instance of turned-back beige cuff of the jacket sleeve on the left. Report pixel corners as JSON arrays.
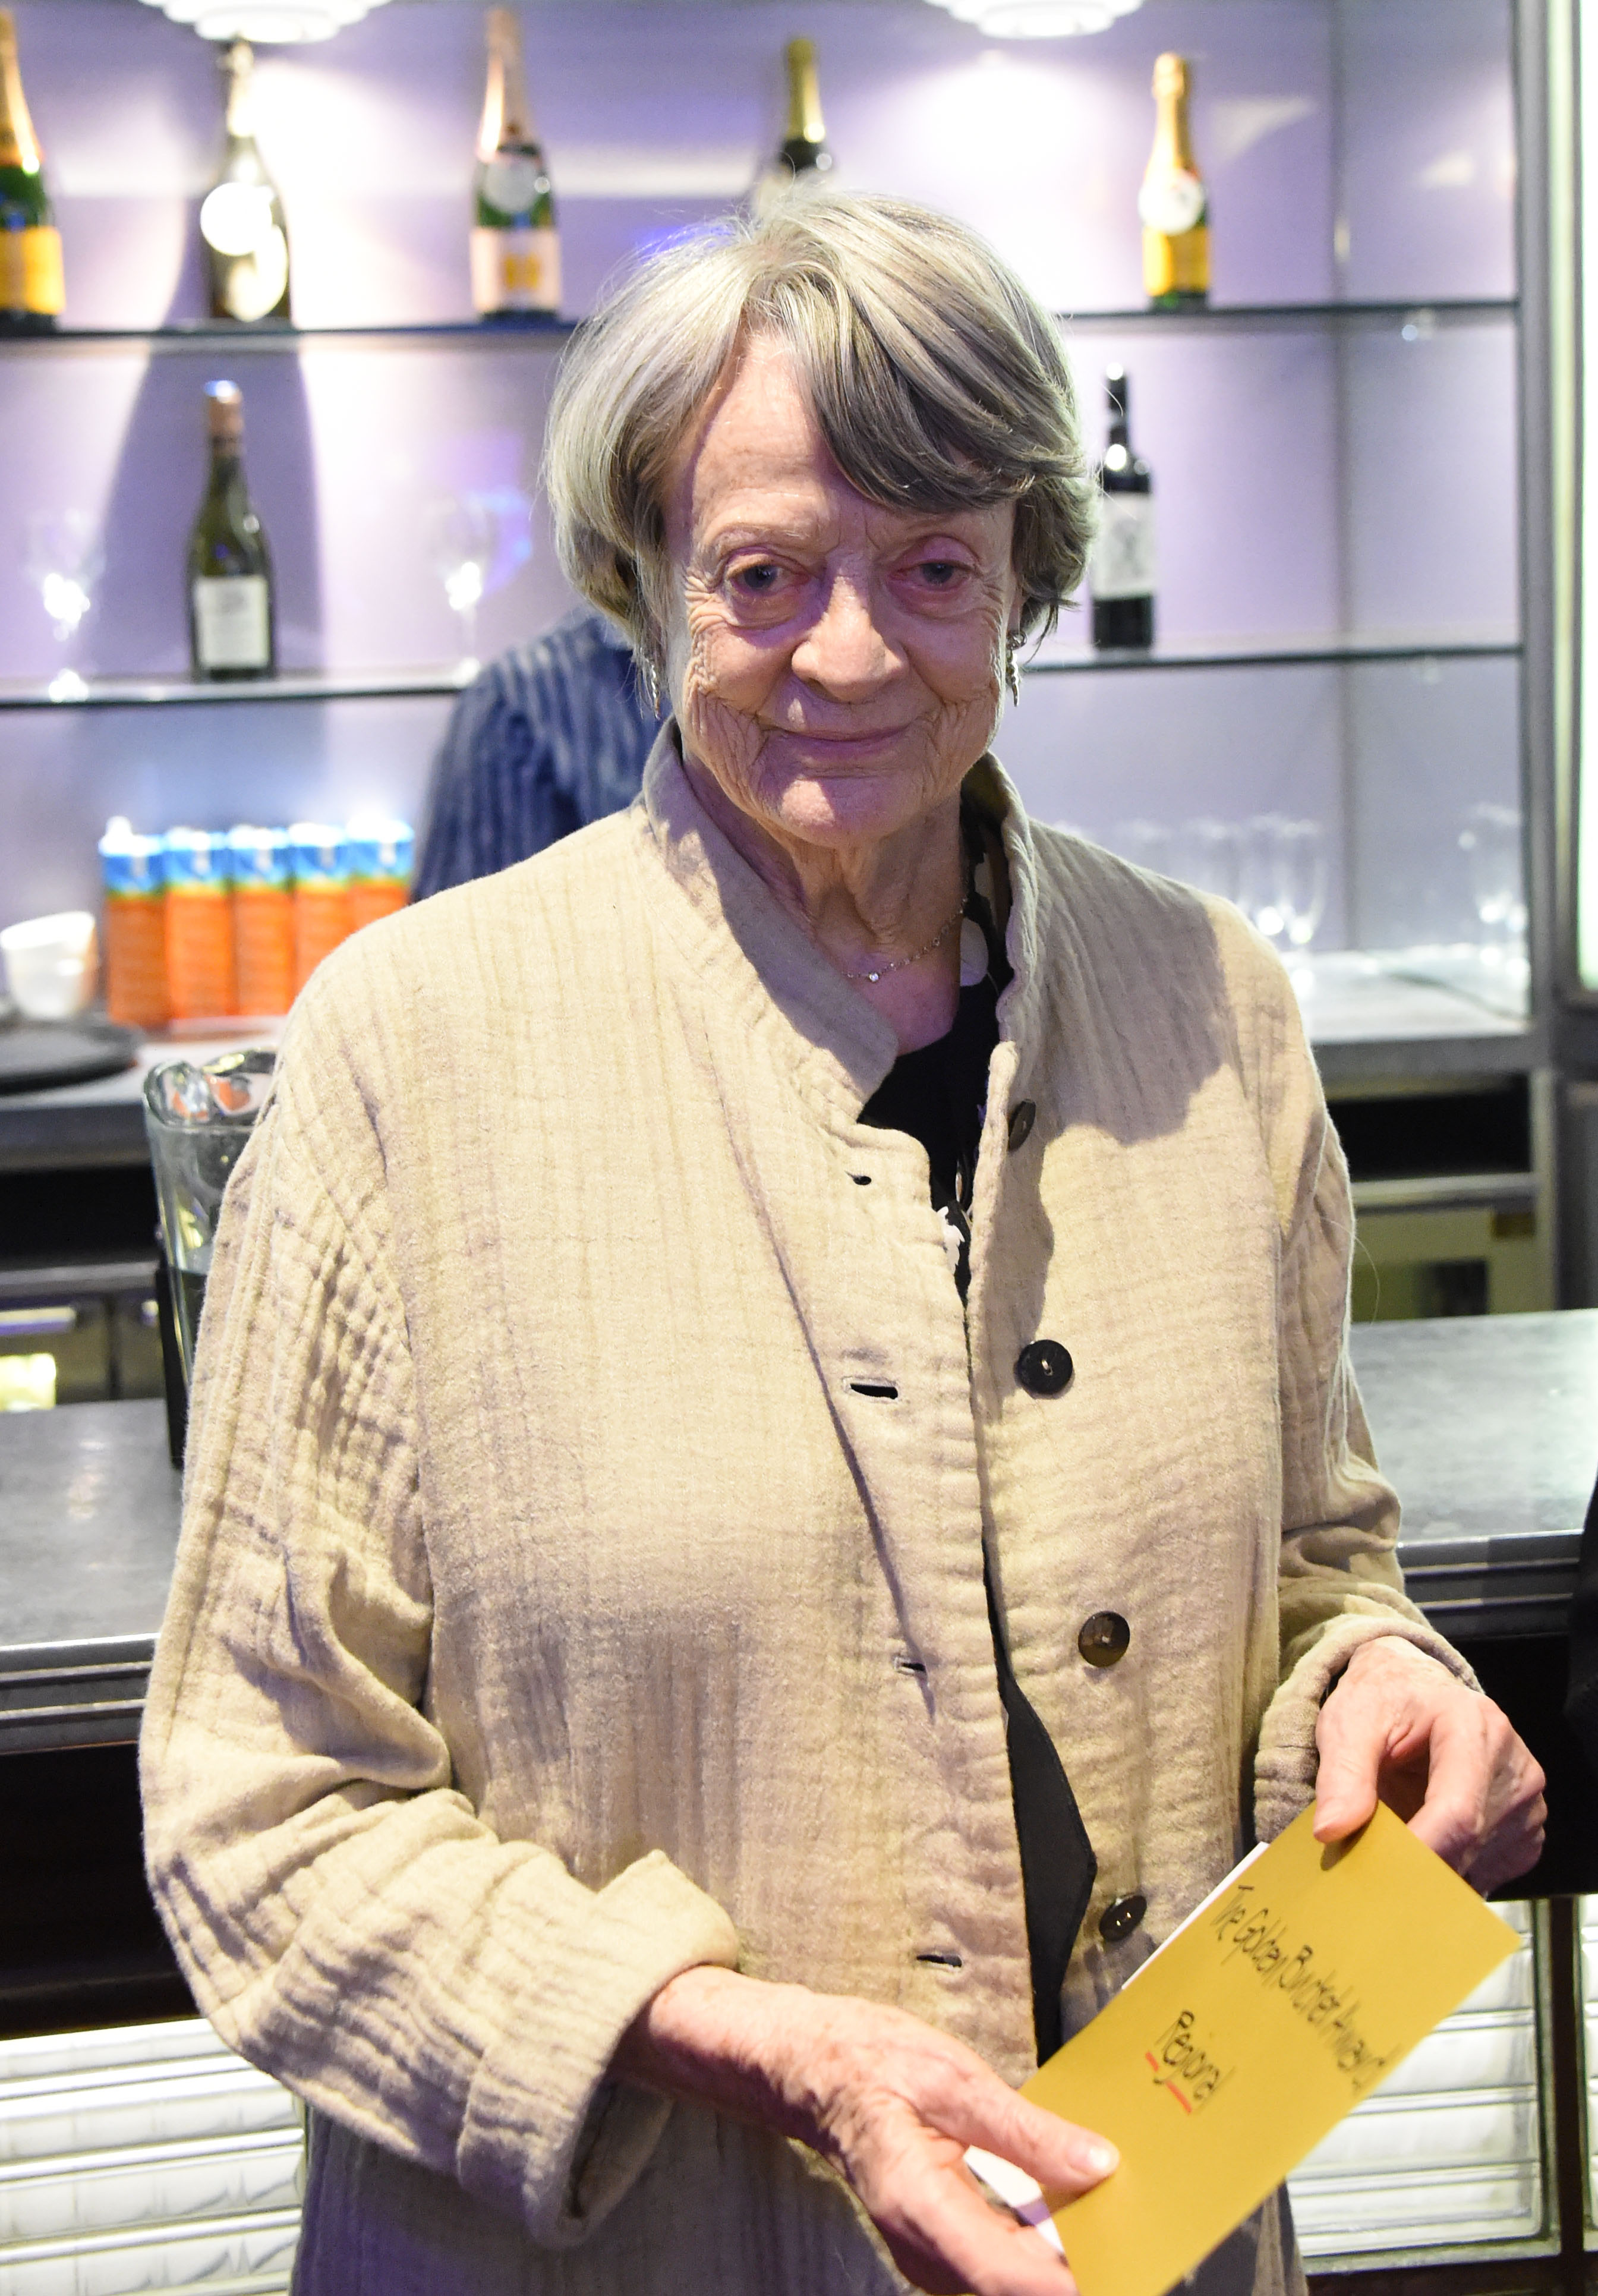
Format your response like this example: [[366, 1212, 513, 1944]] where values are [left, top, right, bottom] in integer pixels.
[[457, 1851, 737, 2248]]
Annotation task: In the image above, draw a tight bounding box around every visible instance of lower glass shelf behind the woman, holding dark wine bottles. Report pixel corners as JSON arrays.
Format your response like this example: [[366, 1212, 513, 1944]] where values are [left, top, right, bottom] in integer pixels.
[[0, 636, 1520, 710]]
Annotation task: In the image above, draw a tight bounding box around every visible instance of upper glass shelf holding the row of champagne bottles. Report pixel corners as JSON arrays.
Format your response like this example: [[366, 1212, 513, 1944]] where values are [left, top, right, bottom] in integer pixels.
[[0, 296, 1520, 351]]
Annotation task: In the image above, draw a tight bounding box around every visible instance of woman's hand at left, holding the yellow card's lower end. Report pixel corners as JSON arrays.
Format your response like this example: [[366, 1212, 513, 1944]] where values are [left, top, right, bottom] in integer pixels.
[[613, 1968, 1116, 2296]]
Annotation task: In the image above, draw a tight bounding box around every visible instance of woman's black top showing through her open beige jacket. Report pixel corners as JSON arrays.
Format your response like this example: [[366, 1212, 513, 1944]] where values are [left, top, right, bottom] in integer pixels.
[[861, 808, 1098, 2064]]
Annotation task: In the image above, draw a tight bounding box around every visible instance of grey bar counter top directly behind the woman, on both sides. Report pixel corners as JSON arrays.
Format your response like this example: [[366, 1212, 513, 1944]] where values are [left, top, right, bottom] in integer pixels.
[[0, 1309, 1598, 1752]]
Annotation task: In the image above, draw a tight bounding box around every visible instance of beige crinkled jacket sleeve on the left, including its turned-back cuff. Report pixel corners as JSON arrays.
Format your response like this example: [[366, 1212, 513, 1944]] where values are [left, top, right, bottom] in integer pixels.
[[140, 964, 737, 2245]]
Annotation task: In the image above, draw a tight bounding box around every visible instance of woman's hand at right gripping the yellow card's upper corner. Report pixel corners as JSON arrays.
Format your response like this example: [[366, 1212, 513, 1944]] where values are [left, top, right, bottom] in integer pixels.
[[1316, 1634, 1547, 1892]]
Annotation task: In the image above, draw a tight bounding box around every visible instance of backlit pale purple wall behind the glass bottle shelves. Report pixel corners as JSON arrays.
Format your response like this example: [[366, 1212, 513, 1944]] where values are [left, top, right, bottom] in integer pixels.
[[0, 0, 1515, 941]]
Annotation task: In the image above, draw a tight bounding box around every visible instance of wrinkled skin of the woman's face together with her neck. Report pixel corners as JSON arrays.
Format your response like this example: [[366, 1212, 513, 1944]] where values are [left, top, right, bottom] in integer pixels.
[[666, 338, 1019, 1047]]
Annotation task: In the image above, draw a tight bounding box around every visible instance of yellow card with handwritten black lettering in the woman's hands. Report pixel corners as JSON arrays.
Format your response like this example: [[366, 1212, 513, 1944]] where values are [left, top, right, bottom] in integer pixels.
[[971, 1807, 1520, 2296]]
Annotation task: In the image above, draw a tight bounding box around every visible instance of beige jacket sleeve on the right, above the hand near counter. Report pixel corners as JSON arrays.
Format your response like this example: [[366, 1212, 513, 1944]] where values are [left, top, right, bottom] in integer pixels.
[[1231, 914, 1476, 1841]]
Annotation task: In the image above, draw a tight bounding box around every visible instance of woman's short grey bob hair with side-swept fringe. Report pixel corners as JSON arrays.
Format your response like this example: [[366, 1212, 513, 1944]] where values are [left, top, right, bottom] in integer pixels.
[[544, 188, 1095, 675]]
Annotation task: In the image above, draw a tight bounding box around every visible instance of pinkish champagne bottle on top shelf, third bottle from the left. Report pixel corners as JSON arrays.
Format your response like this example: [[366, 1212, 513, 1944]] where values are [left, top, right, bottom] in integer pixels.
[[471, 7, 560, 319]]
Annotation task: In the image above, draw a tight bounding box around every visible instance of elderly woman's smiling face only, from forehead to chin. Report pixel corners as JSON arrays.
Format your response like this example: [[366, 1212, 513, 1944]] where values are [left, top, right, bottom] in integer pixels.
[[666, 338, 1017, 847]]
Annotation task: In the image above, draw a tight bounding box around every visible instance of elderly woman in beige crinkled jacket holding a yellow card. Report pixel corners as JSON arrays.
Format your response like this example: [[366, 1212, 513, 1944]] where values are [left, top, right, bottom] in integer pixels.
[[143, 195, 1540, 2296]]
